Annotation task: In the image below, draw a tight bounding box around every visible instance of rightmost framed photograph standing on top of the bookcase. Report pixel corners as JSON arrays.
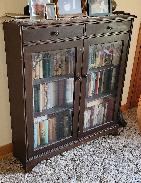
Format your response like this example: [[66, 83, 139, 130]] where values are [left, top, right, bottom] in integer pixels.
[[88, 0, 112, 16]]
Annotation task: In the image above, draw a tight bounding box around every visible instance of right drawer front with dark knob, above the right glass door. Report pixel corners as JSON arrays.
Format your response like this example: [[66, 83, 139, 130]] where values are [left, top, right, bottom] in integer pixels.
[[86, 21, 131, 36]]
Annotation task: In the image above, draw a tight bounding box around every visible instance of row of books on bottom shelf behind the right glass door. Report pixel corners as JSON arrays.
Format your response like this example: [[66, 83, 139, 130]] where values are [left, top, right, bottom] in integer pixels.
[[84, 98, 114, 130]]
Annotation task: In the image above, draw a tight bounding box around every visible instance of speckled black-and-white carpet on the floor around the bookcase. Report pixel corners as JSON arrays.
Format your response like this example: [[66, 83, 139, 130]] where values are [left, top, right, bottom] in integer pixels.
[[0, 109, 141, 183]]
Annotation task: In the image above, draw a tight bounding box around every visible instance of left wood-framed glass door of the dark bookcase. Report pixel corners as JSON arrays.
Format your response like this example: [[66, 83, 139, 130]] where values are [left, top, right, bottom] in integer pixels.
[[25, 40, 83, 156]]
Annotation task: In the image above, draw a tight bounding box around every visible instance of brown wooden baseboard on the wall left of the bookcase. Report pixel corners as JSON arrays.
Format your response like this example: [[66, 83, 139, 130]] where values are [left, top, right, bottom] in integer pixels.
[[0, 143, 13, 159]]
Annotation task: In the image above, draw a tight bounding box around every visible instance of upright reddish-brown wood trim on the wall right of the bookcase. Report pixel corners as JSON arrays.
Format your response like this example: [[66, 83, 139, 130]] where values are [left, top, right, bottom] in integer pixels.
[[127, 24, 141, 108]]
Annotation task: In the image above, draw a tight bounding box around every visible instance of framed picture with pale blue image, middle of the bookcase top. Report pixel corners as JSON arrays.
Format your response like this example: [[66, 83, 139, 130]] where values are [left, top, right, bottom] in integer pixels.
[[57, 0, 82, 17]]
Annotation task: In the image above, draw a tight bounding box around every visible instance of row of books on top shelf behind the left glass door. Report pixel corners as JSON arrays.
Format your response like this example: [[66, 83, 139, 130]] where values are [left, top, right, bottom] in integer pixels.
[[32, 48, 75, 80]]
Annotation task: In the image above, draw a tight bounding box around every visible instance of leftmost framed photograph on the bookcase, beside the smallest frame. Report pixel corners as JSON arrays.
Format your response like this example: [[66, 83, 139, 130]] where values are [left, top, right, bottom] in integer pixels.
[[29, 0, 50, 19]]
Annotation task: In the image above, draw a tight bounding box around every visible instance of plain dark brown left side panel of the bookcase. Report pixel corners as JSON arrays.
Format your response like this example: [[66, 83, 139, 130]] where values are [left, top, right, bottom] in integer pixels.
[[4, 23, 26, 165]]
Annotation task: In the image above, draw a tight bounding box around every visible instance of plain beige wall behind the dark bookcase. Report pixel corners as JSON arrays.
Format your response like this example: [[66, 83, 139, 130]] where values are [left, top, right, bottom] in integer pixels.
[[0, 0, 141, 146]]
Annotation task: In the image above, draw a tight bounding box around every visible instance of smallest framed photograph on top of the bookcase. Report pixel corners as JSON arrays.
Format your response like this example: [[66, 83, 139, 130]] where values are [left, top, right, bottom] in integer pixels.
[[46, 3, 56, 19]]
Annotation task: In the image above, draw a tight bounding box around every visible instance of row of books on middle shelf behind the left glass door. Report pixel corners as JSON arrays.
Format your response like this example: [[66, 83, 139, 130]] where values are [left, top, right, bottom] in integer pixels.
[[33, 78, 74, 112]]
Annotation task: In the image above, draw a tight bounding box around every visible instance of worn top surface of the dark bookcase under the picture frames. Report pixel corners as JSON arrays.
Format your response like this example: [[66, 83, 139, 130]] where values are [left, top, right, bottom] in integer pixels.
[[3, 14, 135, 27]]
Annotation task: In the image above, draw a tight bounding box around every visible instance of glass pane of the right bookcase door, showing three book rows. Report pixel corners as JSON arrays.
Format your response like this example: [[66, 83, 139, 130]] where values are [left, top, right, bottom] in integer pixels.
[[81, 41, 122, 132]]
